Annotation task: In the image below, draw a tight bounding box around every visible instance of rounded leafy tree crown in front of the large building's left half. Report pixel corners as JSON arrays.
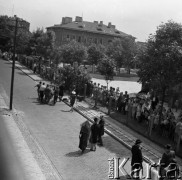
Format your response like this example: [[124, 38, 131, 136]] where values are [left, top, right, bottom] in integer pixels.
[[60, 40, 87, 64]]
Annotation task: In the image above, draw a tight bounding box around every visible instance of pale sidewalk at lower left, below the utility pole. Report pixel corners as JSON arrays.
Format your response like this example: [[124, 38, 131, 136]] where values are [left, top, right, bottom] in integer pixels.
[[0, 94, 46, 180]]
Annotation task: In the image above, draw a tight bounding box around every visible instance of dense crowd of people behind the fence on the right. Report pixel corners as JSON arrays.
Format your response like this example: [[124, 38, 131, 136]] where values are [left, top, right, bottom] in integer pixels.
[[92, 83, 182, 151]]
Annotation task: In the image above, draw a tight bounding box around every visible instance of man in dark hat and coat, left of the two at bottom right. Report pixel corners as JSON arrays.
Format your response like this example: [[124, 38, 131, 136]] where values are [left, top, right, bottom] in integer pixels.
[[131, 139, 143, 178]]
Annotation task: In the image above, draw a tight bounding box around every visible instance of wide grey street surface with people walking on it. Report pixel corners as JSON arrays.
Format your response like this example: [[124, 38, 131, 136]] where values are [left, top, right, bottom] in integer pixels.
[[0, 60, 134, 180]]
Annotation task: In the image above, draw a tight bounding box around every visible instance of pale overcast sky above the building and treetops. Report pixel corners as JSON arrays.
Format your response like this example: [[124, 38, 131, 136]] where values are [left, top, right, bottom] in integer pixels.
[[0, 0, 182, 42]]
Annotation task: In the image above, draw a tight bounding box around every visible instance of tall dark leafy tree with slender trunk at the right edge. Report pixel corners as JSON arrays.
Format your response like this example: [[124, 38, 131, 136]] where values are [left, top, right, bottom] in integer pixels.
[[138, 21, 182, 124]]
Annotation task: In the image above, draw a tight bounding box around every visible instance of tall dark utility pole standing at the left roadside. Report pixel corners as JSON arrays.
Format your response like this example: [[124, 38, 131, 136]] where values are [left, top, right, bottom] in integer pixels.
[[9, 15, 18, 110]]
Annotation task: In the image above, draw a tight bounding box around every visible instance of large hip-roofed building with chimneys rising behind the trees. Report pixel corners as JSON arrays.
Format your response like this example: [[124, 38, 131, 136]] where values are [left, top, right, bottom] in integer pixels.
[[47, 16, 135, 46]]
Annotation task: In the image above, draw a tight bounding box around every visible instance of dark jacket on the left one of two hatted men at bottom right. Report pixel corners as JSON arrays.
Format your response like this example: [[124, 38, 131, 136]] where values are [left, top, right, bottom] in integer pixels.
[[131, 144, 143, 166]]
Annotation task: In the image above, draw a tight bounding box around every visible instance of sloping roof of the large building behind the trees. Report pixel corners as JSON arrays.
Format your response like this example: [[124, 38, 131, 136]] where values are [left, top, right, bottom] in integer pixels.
[[47, 21, 132, 37]]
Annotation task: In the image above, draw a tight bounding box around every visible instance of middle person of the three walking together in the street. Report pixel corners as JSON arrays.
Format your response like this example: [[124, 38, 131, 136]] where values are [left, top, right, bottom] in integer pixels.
[[90, 118, 99, 151]]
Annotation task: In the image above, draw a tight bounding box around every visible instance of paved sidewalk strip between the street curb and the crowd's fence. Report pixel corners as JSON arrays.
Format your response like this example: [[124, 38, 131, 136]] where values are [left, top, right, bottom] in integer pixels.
[[12, 62, 182, 169]]
